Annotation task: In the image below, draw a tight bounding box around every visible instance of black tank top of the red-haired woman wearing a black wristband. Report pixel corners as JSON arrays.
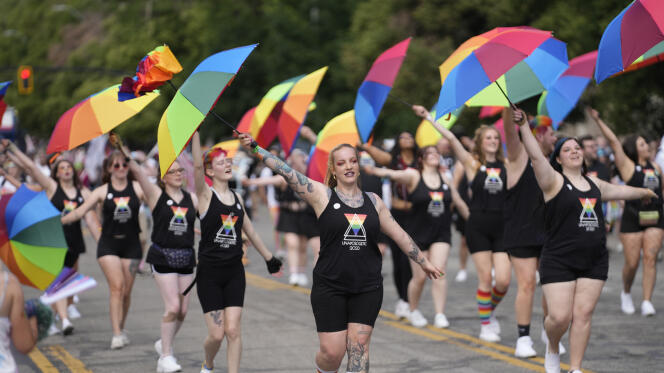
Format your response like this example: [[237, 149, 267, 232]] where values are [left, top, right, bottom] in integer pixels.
[[198, 188, 244, 265]]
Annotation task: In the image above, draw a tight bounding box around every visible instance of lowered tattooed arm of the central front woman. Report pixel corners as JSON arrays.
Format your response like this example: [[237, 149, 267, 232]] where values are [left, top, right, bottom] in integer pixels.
[[369, 193, 445, 280]]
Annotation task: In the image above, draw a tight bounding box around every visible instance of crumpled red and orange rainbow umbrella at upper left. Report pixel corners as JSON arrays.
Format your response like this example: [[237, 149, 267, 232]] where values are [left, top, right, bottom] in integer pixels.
[[118, 45, 182, 101]]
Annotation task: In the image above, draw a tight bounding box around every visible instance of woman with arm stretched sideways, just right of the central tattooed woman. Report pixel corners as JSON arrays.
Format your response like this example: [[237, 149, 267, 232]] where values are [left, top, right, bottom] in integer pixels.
[[369, 146, 468, 328]]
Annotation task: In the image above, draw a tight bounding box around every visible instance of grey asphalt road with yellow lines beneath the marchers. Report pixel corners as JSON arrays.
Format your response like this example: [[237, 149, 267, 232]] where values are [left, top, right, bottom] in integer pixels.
[[15, 202, 664, 373]]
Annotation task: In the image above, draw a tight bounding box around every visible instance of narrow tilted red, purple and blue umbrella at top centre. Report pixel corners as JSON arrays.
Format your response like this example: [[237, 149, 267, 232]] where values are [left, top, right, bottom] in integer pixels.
[[354, 38, 411, 142]]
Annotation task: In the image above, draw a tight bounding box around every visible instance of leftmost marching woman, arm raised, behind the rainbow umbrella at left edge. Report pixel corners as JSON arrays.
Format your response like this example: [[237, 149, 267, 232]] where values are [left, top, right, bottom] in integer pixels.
[[3, 140, 100, 335]]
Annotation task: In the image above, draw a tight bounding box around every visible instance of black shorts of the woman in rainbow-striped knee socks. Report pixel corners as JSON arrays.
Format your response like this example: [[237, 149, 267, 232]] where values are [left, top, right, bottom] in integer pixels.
[[466, 212, 506, 254]]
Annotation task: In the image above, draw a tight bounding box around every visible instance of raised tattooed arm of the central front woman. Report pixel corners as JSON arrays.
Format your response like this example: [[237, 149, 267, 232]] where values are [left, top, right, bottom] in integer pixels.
[[239, 133, 329, 215]]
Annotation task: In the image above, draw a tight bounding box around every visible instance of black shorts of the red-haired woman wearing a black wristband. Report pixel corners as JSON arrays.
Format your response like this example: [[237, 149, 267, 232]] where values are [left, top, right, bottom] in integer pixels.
[[196, 260, 247, 313]]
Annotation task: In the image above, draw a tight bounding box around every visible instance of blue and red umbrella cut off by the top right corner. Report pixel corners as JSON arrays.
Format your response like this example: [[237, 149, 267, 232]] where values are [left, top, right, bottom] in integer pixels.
[[595, 0, 664, 84]]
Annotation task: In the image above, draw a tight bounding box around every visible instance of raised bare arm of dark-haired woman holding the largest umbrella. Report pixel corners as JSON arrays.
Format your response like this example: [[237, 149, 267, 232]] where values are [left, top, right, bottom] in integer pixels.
[[515, 111, 563, 201]]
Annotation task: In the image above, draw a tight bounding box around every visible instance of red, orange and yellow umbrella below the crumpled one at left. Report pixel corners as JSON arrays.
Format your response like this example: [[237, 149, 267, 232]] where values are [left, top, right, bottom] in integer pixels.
[[46, 84, 159, 153]]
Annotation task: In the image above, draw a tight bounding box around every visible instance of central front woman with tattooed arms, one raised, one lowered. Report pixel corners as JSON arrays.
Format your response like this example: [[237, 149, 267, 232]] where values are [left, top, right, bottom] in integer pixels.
[[240, 134, 442, 373]]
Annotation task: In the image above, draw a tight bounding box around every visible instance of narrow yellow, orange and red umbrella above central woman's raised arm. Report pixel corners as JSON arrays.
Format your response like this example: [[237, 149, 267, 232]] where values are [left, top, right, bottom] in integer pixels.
[[277, 66, 327, 158]]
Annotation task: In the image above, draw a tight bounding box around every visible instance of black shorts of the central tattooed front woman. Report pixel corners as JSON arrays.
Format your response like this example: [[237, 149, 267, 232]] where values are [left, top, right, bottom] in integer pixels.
[[311, 276, 383, 333]]
